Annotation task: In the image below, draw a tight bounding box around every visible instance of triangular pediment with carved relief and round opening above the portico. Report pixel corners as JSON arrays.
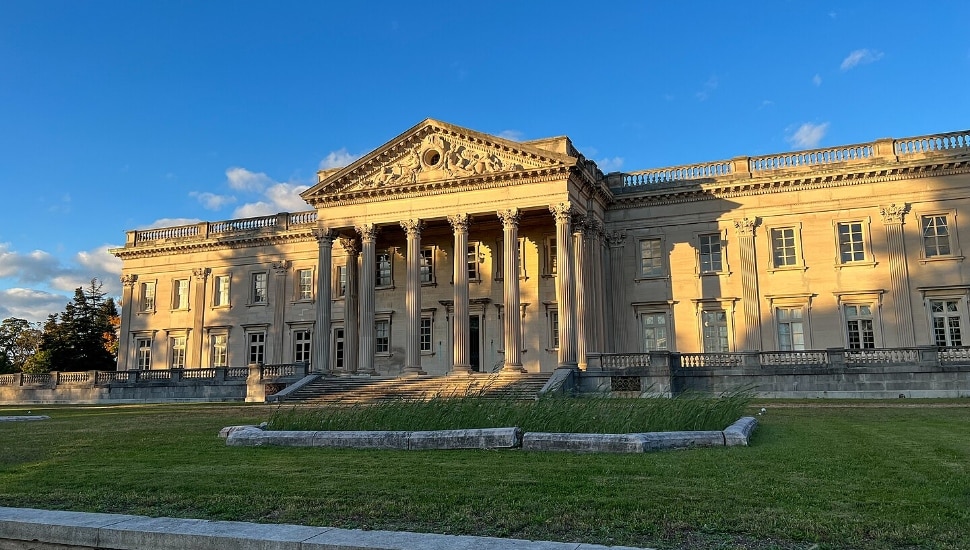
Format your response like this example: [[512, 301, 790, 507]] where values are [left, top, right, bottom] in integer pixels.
[[300, 119, 577, 204]]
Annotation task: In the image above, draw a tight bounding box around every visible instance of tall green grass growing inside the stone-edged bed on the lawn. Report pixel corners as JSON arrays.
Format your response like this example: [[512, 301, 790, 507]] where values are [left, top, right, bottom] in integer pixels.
[[267, 392, 751, 434]]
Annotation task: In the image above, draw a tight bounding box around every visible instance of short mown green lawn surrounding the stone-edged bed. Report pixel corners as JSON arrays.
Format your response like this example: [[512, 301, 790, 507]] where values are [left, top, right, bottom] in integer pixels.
[[0, 400, 970, 550]]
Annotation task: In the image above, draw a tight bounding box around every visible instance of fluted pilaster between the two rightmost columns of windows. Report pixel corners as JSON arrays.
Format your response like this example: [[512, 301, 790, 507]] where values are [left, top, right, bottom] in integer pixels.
[[879, 204, 916, 348]]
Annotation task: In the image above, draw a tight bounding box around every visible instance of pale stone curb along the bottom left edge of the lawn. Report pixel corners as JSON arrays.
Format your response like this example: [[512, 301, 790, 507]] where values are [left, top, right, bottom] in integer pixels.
[[0, 507, 648, 550]]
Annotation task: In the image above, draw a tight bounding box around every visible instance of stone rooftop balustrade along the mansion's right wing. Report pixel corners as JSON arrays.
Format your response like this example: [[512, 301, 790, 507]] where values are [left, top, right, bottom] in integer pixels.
[[610, 131, 970, 188]]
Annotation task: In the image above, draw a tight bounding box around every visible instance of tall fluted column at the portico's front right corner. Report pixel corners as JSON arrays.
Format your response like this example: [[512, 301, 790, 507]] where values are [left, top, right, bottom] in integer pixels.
[[549, 205, 576, 369]]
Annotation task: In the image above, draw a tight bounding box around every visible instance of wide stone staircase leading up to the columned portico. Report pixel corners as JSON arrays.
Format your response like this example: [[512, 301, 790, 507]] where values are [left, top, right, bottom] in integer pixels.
[[285, 373, 550, 405]]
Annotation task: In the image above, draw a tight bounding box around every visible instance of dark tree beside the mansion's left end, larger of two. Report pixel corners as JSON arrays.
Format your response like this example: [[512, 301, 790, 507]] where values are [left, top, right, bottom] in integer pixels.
[[31, 279, 118, 372]]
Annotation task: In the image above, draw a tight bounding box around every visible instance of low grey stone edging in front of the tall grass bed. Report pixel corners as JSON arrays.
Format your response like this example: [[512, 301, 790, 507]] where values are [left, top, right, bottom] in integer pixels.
[[225, 416, 758, 453]]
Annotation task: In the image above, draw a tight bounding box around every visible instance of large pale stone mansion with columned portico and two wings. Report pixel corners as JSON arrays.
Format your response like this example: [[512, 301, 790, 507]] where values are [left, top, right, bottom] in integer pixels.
[[113, 119, 970, 376]]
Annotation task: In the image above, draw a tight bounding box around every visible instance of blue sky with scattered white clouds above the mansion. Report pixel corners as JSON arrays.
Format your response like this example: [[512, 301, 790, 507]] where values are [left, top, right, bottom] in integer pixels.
[[0, 0, 970, 321]]
